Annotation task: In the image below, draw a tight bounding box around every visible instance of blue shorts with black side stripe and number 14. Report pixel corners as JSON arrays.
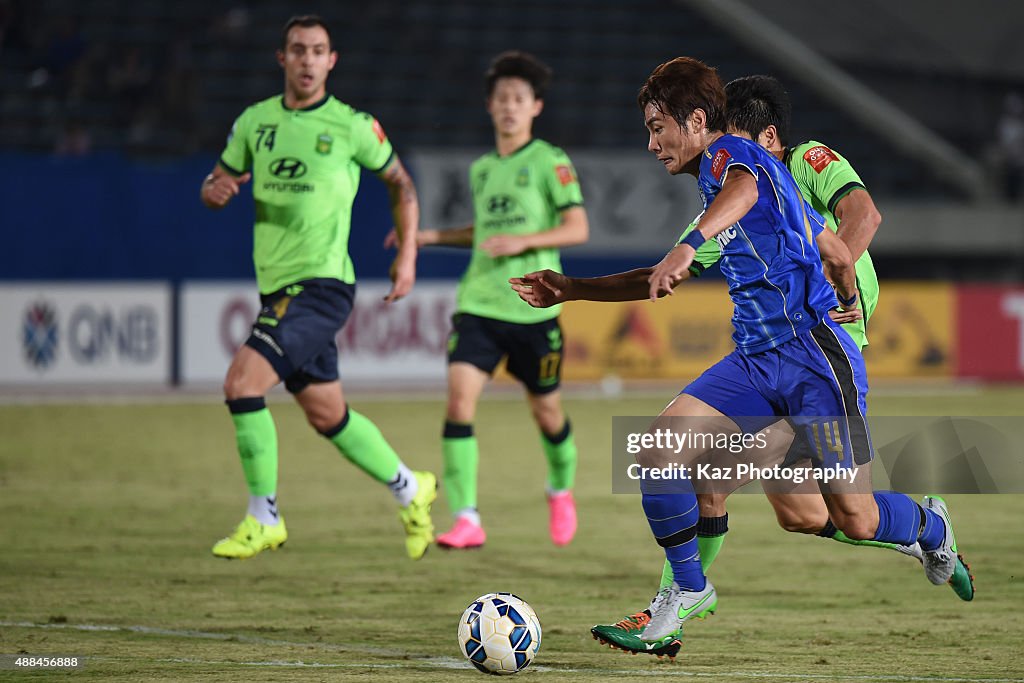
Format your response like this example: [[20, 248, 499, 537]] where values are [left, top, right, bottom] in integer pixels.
[[683, 317, 872, 466]]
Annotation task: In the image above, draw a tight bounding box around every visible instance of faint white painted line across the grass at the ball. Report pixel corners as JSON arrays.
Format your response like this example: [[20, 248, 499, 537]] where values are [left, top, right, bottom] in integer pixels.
[[0, 622, 1024, 683]]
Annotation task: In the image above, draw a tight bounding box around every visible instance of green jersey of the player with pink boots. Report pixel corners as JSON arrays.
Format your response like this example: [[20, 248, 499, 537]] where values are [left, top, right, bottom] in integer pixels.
[[456, 139, 583, 325]]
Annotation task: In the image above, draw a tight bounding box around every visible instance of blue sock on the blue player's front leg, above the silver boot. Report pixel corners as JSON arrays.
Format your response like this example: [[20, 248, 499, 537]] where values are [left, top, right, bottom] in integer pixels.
[[642, 493, 708, 591]]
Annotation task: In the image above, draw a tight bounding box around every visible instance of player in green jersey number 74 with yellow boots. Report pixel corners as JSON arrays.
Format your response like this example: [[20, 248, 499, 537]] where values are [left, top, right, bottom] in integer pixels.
[[201, 15, 437, 559]]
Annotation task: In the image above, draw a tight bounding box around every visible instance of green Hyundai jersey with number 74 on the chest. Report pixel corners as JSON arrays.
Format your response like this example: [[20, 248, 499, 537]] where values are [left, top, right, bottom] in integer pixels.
[[220, 95, 392, 294]]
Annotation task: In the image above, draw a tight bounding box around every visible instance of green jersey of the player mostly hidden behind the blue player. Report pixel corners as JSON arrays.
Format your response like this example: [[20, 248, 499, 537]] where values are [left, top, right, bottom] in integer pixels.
[[680, 140, 879, 348]]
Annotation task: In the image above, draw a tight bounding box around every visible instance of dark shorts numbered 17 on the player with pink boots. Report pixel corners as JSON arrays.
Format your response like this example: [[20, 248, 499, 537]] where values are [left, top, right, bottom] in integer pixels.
[[449, 313, 562, 394]]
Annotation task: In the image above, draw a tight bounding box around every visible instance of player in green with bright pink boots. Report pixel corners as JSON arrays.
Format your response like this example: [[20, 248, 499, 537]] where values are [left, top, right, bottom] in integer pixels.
[[387, 51, 589, 549]]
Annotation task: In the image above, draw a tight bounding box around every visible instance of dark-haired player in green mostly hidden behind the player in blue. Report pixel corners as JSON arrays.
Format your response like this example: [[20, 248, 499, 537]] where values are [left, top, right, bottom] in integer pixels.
[[591, 76, 974, 656]]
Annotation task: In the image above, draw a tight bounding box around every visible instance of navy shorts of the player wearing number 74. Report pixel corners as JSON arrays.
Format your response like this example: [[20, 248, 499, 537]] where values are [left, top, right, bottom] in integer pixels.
[[246, 278, 355, 393]]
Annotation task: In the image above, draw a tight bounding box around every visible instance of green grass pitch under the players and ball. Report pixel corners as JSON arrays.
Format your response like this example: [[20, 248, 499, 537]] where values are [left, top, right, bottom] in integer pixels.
[[0, 388, 1024, 682]]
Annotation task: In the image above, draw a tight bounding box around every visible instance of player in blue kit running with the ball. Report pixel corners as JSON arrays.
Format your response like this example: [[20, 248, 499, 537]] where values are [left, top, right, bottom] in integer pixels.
[[512, 57, 956, 647]]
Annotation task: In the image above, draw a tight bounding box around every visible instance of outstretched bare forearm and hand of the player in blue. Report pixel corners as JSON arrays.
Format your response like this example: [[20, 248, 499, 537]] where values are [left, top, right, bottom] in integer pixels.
[[509, 268, 690, 308]]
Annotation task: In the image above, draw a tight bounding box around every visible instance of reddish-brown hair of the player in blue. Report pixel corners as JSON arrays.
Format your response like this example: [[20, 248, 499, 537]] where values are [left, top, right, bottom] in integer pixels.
[[637, 57, 725, 131]]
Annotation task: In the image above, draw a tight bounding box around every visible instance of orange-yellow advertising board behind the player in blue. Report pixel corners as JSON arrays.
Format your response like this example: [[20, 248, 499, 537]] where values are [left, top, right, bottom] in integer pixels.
[[561, 282, 956, 382]]
